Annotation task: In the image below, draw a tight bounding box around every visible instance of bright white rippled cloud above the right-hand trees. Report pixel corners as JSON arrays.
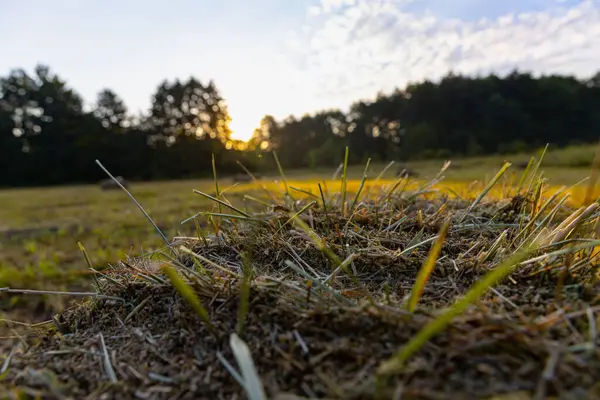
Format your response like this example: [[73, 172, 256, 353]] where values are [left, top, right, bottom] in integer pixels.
[[290, 0, 600, 112]]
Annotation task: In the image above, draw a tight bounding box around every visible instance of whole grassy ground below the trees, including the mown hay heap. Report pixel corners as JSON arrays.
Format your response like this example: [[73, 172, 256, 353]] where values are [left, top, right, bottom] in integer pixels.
[[0, 148, 600, 399]]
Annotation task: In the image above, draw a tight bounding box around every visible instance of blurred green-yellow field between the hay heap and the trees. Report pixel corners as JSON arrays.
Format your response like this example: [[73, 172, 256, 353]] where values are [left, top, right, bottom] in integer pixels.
[[0, 146, 595, 294]]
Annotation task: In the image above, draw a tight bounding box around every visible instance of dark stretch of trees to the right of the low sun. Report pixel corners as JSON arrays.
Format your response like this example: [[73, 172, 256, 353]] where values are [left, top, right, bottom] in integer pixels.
[[254, 71, 600, 167]]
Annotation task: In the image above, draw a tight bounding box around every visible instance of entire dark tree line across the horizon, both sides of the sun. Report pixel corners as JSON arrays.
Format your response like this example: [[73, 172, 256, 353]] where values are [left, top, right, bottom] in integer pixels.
[[0, 65, 600, 186]]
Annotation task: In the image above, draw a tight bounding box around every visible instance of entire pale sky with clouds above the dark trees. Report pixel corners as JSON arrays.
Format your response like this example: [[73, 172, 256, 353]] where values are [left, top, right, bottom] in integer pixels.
[[0, 0, 600, 139]]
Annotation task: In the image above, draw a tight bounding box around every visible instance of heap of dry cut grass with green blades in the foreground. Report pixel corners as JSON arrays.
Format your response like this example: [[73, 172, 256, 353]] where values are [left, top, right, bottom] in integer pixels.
[[0, 152, 600, 400]]
